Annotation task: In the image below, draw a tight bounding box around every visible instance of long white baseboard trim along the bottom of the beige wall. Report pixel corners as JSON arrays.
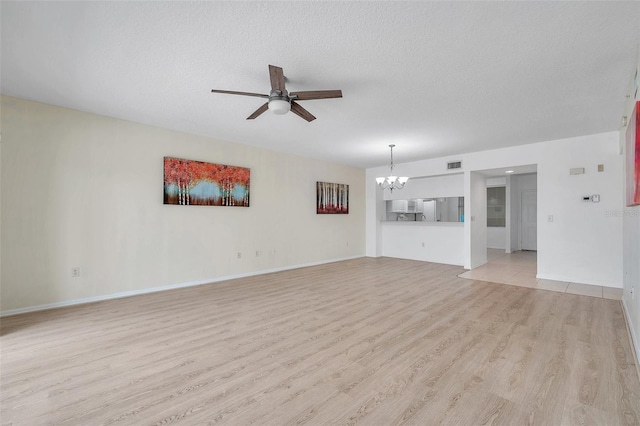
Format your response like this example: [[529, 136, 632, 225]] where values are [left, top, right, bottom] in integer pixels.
[[0, 256, 363, 317]]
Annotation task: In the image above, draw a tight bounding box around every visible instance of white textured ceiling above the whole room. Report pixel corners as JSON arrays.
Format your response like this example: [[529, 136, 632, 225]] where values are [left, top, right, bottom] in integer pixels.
[[0, 1, 640, 167]]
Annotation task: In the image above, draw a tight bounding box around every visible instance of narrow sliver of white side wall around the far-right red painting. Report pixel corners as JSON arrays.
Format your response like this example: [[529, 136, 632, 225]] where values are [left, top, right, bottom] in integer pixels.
[[610, 46, 640, 362]]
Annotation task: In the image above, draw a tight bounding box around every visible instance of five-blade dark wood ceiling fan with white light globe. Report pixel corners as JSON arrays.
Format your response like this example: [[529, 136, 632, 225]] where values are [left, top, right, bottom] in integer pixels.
[[211, 65, 342, 121]]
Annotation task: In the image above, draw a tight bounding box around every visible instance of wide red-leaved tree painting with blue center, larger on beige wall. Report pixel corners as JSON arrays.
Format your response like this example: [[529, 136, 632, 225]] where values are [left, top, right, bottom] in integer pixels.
[[164, 157, 250, 207]]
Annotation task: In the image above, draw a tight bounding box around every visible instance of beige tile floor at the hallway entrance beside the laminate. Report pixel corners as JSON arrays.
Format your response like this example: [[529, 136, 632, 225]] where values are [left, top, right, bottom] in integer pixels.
[[458, 249, 622, 300]]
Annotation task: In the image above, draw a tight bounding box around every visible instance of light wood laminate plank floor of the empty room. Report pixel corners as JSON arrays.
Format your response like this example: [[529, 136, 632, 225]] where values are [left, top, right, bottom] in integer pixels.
[[0, 258, 640, 425]]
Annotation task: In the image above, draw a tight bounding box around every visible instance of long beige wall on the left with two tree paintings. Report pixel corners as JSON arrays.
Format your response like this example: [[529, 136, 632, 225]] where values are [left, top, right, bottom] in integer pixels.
[[0, 97, 365, 312]]
